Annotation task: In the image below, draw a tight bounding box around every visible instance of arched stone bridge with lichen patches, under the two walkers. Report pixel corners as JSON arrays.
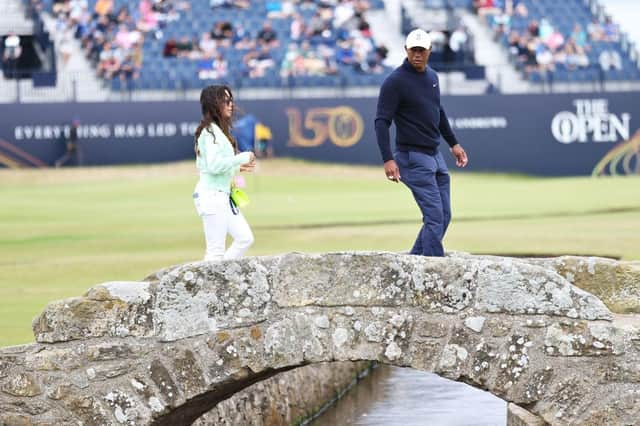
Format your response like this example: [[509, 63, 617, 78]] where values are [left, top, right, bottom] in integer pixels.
[[0, 253, 640, 425]]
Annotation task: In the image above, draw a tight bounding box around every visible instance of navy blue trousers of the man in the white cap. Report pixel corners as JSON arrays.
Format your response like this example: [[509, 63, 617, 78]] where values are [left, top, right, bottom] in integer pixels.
[[395, 151, 451, 256]]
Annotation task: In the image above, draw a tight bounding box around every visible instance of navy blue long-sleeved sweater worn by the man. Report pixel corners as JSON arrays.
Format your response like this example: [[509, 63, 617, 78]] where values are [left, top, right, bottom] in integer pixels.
[[375, 59, 458, 161]]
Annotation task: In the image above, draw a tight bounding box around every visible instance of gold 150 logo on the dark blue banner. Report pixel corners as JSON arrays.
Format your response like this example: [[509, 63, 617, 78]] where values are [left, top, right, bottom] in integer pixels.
[[287, 106, 364, 148]]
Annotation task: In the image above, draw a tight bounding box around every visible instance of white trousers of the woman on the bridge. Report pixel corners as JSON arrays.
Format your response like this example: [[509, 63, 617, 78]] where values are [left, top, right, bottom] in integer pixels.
[[194, 191, 253, 260]]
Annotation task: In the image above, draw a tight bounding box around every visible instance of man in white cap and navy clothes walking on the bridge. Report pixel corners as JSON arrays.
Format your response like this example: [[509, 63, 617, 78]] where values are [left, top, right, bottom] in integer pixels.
[[375, 29, 468, 256]]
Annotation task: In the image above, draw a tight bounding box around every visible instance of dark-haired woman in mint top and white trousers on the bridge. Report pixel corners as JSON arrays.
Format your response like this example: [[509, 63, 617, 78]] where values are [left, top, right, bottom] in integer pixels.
[[193, 85, 255, 260]]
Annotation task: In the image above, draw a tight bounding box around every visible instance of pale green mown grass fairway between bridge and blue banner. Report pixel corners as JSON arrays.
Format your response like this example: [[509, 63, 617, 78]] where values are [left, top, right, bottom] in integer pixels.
[[0, 160, 640, 346]]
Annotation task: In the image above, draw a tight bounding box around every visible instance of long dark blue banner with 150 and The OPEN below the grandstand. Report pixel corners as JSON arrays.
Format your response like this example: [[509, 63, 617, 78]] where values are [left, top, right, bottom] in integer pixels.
[[0, 92, 640, 176]]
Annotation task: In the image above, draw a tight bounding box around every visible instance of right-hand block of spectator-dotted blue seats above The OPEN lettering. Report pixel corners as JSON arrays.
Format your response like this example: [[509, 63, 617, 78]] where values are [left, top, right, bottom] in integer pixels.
[[490, 0, 640, 88]]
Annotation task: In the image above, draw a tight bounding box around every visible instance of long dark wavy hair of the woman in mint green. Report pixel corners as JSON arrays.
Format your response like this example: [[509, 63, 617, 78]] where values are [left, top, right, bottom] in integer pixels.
[[194, 85, 237, 155]]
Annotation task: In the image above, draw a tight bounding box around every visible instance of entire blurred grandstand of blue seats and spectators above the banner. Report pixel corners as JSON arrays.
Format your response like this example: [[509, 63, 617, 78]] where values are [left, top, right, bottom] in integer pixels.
[[0, 0, 640, 102]]
